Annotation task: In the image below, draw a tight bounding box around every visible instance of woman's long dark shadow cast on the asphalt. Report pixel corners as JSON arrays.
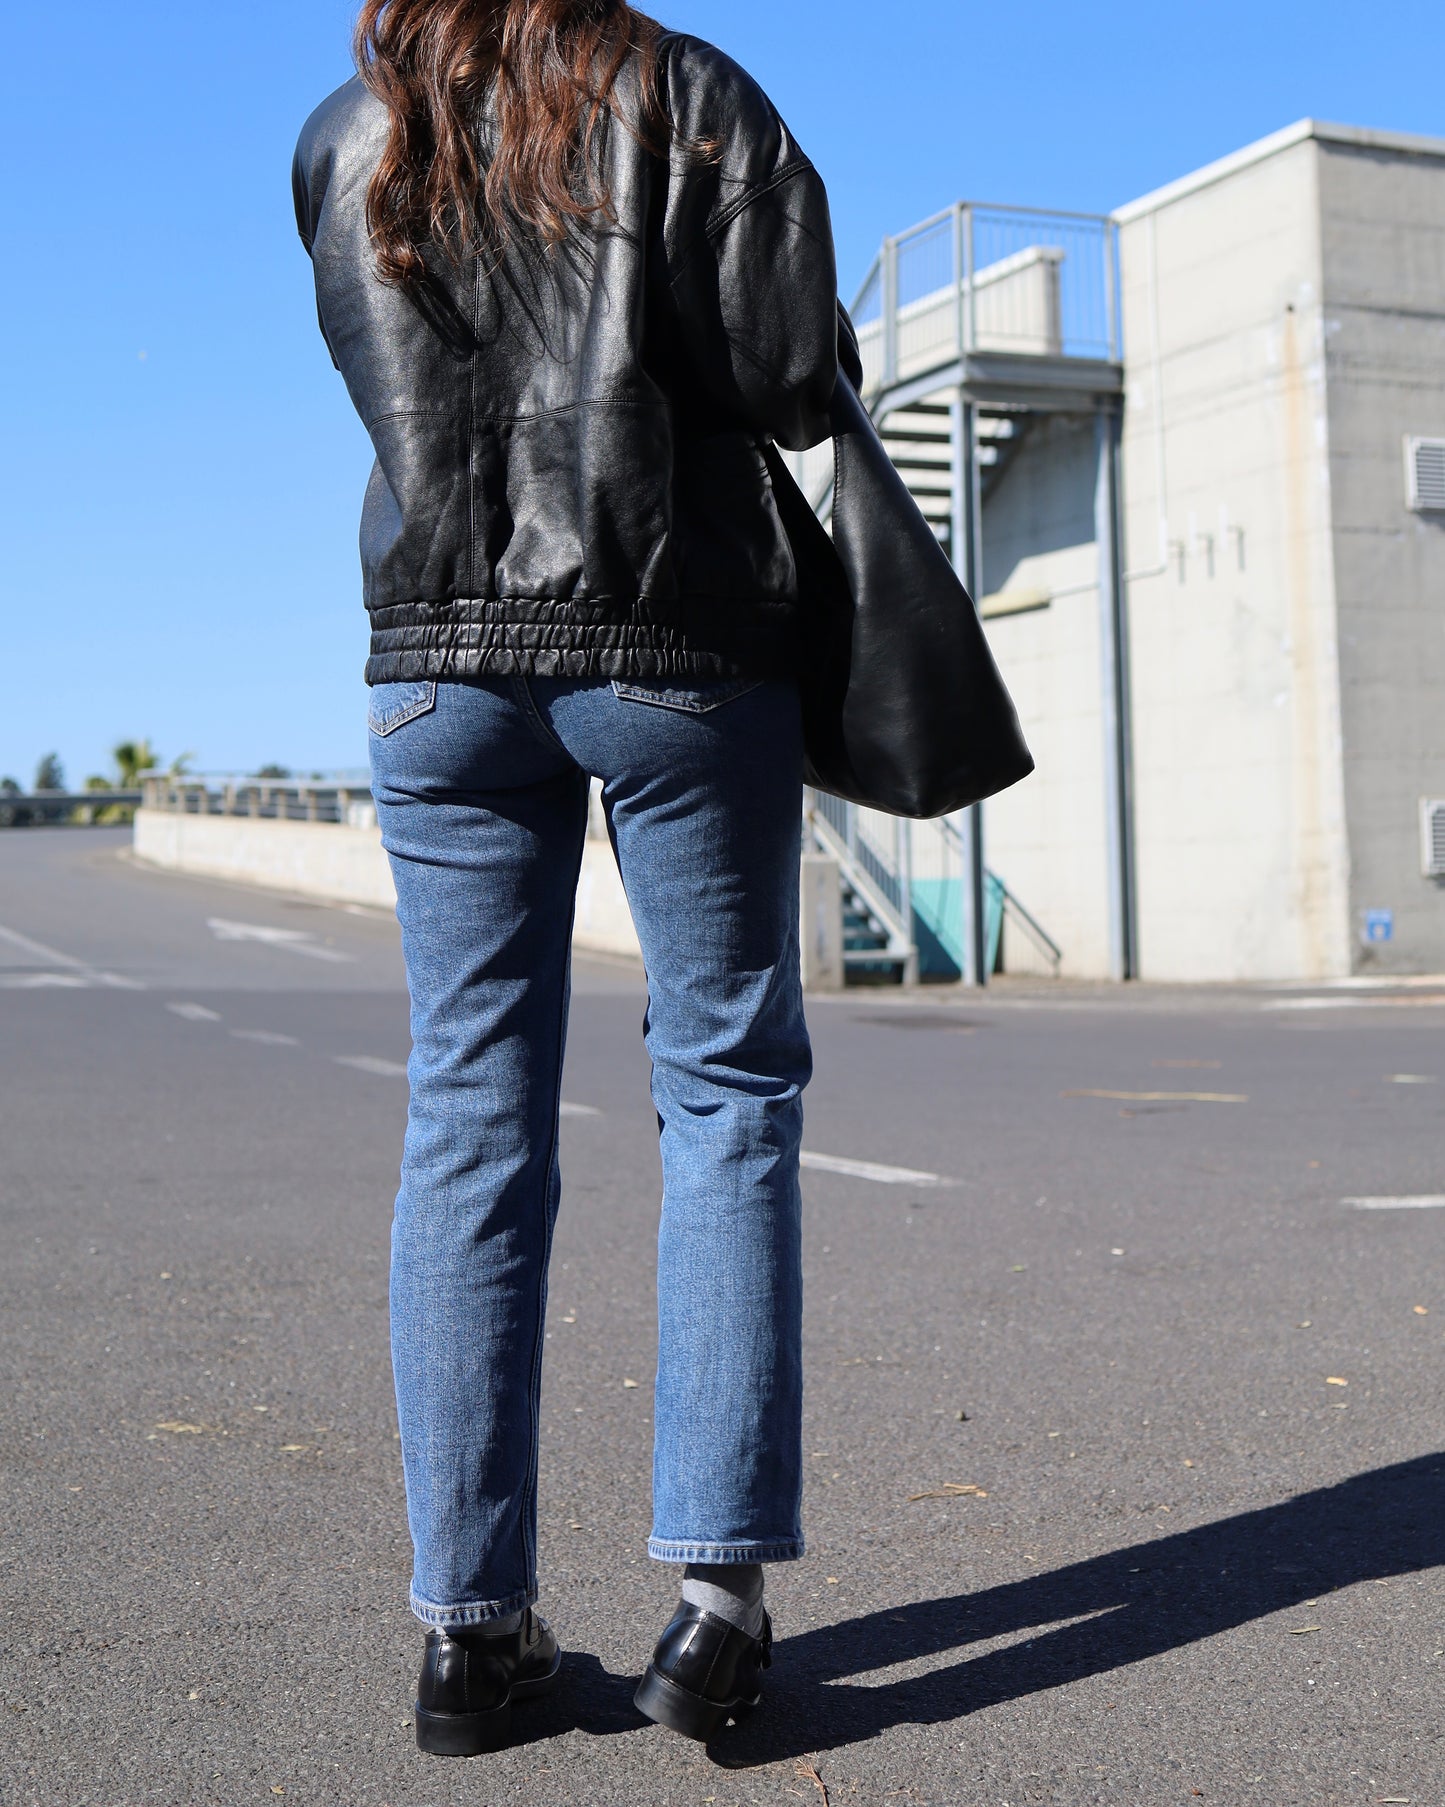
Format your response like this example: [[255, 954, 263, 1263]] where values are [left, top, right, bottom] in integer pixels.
[[502, 1451, 1445, 1769]]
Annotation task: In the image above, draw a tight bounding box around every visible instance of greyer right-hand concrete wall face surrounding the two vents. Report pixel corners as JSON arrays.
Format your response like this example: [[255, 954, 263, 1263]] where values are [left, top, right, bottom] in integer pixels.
[[1319, 144, 1445, 972]]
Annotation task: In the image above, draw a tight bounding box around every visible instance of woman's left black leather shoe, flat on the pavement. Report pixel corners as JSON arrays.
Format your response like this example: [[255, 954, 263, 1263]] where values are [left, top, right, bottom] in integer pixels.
[[417, 1606, 562, 1756]]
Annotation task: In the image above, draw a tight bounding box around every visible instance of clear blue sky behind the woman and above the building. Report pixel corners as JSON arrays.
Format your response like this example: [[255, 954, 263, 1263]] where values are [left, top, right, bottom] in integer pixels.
[[0, 0, 1445, 782]]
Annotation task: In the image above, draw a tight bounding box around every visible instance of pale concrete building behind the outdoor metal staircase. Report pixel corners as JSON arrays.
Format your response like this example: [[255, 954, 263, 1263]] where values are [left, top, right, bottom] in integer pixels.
[[804, 121, 1445, 981]]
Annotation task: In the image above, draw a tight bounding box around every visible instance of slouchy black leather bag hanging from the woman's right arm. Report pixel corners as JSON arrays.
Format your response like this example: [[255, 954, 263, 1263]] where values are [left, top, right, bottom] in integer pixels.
[[768, 342, 1033, 817]]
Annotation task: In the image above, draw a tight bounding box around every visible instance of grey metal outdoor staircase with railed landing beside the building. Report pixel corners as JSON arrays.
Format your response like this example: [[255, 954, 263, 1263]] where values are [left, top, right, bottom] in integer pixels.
[[793, 202, 1133, 985]]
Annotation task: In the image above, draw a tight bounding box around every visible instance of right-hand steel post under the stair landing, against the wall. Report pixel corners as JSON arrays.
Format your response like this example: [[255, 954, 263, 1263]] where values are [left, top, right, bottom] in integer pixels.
[[1095, 403, 1140, 979]]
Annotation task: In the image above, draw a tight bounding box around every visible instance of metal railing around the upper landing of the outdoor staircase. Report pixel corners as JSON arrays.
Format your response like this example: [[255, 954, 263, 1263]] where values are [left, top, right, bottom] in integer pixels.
[[853, 201, 1120, 392]]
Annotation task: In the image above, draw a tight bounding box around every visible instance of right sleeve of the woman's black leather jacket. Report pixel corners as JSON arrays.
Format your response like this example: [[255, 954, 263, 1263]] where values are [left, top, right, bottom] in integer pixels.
[[667, 40, 838, 452]]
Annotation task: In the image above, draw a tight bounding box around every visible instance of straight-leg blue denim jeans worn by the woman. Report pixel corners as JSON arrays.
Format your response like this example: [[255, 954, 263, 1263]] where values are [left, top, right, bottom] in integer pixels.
[[370, 678, 811, 1628]]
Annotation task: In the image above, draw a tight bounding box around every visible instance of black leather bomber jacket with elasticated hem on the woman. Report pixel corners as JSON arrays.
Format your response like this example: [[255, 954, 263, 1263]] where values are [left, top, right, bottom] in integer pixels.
[[294, 34, 838, 683]]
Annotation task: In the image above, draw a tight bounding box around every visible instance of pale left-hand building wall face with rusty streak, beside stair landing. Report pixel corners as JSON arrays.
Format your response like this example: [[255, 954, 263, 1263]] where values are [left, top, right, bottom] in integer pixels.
[[1118, 137, 1349, 979]]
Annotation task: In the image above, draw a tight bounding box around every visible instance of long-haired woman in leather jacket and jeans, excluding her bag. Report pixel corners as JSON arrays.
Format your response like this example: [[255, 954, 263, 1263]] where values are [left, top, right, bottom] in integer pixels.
[[294, 0, 838, 1755]]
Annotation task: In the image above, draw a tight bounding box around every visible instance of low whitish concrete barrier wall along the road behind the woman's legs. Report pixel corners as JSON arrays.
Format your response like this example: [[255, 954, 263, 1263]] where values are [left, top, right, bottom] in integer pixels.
[[134, 810, 641, 960]]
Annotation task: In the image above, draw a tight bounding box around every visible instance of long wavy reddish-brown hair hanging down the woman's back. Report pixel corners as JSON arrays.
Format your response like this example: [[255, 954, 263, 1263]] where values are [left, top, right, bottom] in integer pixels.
[[354, 0, 668, 287]]
